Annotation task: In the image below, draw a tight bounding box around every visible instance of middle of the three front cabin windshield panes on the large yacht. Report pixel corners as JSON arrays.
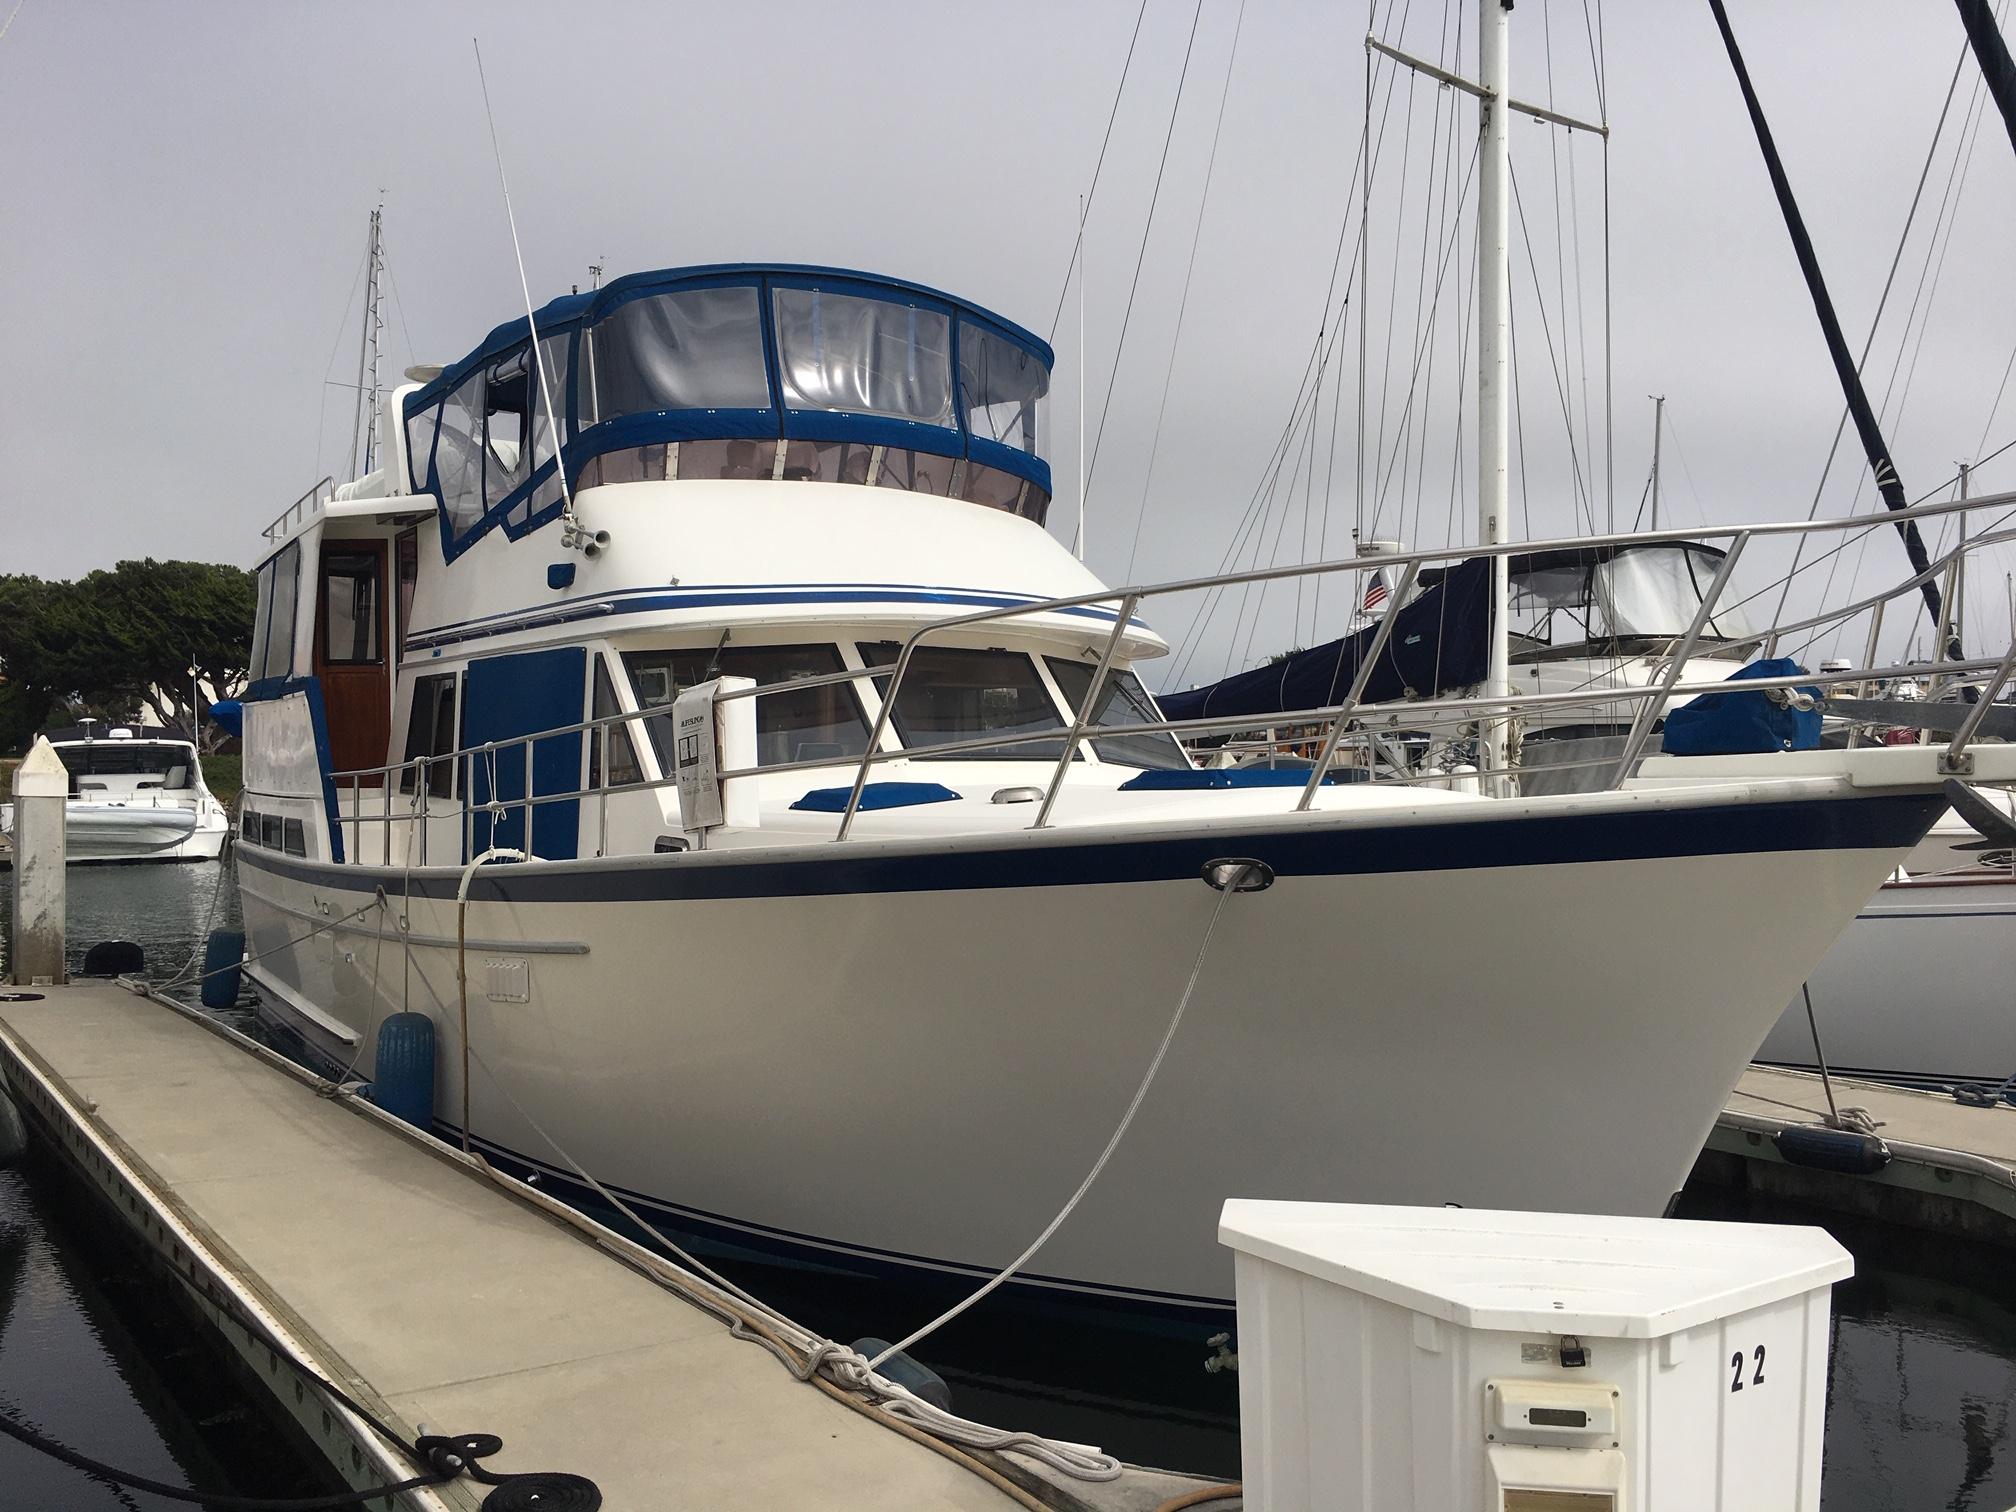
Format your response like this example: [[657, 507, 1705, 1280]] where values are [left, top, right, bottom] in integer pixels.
[[861, 641, 1064, 762]]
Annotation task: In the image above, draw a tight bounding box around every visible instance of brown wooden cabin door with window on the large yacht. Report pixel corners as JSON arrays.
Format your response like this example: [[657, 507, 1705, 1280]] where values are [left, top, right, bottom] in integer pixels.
[[314, 540, 391, 786]]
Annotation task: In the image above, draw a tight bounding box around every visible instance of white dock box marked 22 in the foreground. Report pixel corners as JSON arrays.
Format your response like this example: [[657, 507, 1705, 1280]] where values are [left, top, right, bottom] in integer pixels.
[[1218, 1200, 1855, 1512]]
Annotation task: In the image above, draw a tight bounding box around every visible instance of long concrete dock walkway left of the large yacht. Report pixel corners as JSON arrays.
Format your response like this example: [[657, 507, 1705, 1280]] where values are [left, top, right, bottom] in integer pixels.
[[0, 982, 1238, 1512]]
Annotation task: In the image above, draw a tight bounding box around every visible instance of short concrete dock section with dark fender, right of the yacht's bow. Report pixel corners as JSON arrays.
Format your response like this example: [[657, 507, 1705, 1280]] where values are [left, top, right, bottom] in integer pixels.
[[1695, 1066, 2016, 1244]]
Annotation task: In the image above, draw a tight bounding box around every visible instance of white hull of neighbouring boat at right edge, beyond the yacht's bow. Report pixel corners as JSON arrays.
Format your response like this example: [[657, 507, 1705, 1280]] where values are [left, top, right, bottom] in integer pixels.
[[1758, 869, 2016, 1085]]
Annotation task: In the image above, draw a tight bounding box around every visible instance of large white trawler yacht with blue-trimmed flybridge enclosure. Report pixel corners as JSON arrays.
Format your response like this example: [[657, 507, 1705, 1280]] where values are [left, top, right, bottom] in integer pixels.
[[238, 266, 2016, 1308]]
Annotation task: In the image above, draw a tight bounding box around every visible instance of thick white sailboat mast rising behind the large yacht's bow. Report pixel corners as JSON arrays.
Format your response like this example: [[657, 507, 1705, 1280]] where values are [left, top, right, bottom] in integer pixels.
[[1478, 0, 1512, 790]]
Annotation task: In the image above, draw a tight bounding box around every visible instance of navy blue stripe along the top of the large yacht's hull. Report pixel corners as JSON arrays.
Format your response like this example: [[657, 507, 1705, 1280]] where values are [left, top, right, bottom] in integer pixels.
[[238, 792, 1945, 903]]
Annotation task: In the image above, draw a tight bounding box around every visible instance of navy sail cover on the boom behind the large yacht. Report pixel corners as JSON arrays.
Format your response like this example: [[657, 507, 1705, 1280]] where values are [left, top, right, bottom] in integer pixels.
[[1157, 556, 1492, 720]]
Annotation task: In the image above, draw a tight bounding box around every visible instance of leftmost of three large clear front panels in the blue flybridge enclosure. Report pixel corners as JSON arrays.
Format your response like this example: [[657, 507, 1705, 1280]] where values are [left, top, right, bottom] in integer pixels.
[[579, 288, 770, 429]]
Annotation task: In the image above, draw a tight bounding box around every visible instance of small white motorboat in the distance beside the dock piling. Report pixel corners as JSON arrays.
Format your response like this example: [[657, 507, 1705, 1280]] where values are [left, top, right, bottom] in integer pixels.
[[0, 722, 232, 861]]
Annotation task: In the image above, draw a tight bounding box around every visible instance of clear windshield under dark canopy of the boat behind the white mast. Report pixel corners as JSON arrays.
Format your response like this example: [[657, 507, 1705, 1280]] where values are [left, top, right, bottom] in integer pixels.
[[1512, 542, 1756, 647]]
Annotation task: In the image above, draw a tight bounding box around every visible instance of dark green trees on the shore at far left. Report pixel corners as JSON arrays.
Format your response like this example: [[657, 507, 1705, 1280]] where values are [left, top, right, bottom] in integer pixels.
[[0, 558, 256, 752]]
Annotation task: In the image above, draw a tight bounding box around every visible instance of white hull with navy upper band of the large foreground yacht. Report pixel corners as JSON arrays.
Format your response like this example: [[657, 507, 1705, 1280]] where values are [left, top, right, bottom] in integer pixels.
[[240, 794, 1937, 1304]]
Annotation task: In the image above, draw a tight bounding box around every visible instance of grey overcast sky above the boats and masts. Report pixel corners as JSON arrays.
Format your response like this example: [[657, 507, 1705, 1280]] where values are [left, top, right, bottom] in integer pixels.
[[0, 0, 2016, 675]]
